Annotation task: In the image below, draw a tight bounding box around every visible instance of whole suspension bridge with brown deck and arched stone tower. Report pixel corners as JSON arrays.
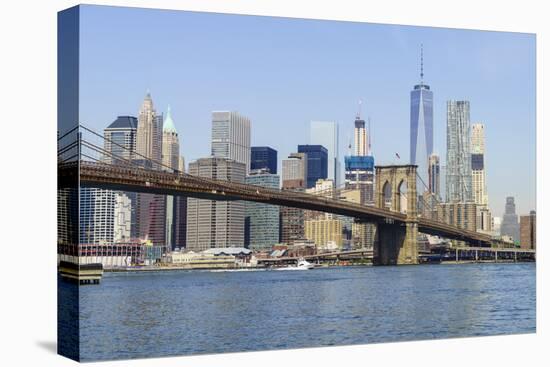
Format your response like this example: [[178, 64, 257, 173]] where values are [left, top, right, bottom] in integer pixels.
[[58, 122, 516, 265]]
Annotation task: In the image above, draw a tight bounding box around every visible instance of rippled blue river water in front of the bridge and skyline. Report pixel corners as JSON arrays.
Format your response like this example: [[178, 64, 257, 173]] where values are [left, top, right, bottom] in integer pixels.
[[67, 263, 536, 361]]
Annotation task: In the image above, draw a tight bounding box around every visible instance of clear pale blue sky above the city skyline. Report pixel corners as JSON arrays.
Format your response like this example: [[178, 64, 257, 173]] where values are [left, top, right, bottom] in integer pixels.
[[80, 6, 536, 216]]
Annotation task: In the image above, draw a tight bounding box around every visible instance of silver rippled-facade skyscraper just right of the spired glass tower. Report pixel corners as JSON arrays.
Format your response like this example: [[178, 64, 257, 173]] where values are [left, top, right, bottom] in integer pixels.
[[446, 101, 473, 202]]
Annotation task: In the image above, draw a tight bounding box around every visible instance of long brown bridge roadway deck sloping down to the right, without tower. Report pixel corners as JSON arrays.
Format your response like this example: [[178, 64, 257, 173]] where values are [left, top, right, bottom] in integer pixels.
[[58, 161, 491, 246]]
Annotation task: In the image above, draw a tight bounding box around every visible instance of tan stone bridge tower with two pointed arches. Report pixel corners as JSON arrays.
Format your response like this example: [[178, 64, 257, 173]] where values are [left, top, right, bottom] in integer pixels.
[[374, 165, 418, 265]]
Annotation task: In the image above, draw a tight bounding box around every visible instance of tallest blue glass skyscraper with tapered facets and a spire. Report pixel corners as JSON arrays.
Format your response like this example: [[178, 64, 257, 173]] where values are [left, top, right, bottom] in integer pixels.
[[410, 49, 433, 190]]
